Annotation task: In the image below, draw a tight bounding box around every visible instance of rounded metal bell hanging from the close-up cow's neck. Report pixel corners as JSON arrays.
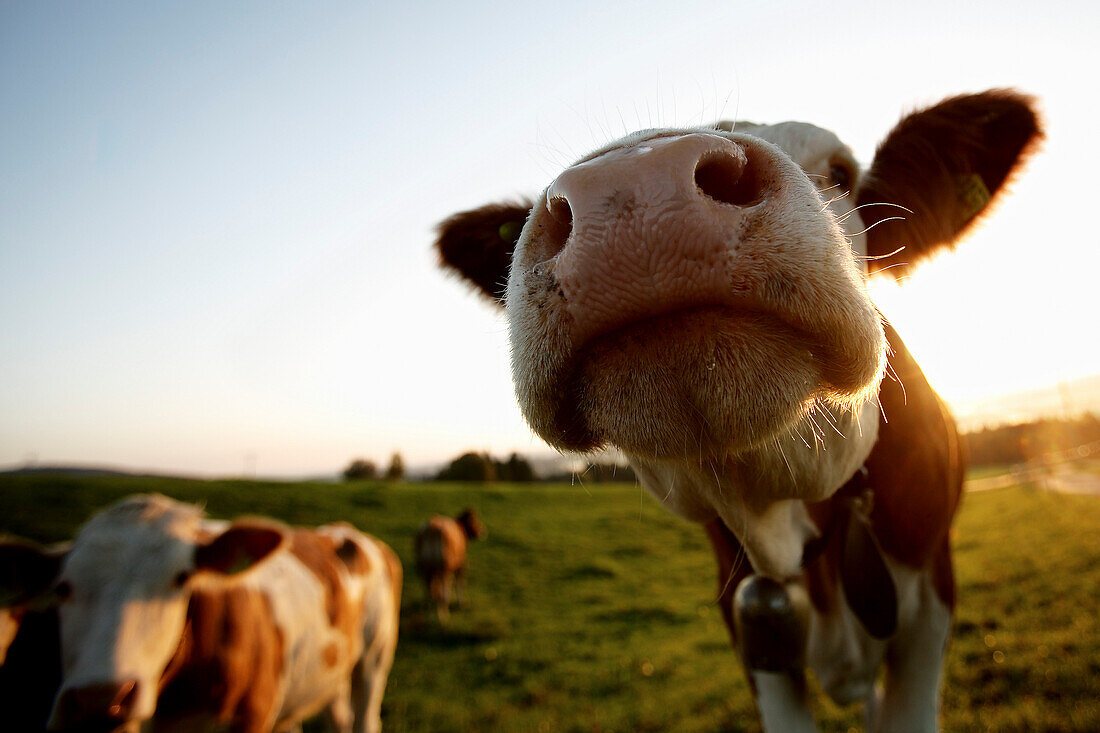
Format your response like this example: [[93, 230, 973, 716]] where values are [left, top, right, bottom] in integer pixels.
[[734, 576, 810, 671]]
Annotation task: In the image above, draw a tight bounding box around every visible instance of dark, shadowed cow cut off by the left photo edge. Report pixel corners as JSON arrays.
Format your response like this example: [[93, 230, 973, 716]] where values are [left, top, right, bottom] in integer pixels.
[[0, 537, 69, 731]]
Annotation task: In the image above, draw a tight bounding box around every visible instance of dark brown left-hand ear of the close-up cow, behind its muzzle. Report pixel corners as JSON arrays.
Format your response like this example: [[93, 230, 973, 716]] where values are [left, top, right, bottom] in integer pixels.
[[436, 200, 531, 305]]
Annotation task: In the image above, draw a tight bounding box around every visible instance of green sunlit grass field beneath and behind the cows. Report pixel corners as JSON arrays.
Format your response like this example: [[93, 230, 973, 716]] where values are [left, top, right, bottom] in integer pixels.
[[0, 475, 1100, 733]]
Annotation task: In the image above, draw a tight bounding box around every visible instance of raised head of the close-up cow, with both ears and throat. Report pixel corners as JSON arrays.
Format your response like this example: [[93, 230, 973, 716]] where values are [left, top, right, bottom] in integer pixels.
[[437, 91, 1040, 576]]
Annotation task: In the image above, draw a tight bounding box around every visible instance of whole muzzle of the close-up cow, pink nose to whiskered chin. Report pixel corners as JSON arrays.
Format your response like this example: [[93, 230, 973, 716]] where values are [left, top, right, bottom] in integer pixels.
[[506, 131, 884, 458]]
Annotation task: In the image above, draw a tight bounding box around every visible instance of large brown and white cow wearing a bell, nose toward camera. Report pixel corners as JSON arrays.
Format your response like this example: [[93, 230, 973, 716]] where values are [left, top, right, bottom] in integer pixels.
[[437, 90, 1042, 731]]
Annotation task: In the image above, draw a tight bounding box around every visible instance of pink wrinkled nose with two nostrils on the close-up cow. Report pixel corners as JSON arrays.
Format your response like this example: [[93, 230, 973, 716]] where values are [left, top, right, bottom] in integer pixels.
[[536, 132, 780, 346]]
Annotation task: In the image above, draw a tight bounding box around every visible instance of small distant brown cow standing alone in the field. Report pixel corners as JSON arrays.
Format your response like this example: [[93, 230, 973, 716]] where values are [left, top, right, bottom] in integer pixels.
[[415, 507, 485, 621]]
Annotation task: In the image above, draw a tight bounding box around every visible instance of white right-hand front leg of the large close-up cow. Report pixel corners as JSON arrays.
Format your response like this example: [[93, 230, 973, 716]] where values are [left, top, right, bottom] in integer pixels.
[[868, 578, 952, 733]]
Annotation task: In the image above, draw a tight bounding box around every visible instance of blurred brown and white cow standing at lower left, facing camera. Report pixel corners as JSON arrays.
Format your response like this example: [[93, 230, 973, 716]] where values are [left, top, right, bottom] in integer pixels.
[[3, 494, 402, 732]]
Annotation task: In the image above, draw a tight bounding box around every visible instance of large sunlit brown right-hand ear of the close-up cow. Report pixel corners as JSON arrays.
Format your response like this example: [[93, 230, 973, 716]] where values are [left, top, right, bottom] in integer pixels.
[[858, 89, 1043, 277]]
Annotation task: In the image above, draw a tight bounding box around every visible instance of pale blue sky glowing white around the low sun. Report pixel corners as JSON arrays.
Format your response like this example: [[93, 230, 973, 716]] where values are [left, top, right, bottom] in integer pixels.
[[0, 0, 1100, 477]]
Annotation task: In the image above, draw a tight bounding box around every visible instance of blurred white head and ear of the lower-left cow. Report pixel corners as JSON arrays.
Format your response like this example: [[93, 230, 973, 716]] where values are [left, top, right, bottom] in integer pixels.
[[50, 495, 284, 731]]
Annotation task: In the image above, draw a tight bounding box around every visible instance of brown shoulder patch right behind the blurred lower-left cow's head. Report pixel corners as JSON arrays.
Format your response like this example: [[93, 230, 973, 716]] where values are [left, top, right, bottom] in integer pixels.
[[157, 587, 284, 733]]
